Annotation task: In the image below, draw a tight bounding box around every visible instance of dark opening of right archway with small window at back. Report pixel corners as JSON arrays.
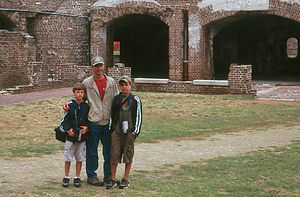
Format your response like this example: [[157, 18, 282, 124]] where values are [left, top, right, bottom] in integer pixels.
[[213, 14, 300, 81]]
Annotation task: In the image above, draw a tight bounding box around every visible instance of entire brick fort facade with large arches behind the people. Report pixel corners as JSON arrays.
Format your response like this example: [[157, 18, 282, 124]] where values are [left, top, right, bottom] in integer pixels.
[[0, 0, 300, 93]]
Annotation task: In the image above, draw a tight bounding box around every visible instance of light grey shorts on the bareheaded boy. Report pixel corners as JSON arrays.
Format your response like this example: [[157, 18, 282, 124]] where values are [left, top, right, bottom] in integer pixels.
[[64, 140, 86, 162]]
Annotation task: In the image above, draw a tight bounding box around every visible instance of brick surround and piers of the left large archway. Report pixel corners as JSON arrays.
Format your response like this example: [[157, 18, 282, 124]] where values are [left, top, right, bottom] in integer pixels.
[[91, 0, 190, 81]]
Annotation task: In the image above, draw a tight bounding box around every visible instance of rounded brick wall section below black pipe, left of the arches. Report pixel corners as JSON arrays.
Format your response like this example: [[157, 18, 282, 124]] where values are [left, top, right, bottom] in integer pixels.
[[29, 15, 89, 87]]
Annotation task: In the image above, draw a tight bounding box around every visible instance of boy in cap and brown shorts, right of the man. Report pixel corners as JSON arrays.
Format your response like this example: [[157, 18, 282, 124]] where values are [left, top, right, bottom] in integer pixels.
[[106, 76, 142, 189]]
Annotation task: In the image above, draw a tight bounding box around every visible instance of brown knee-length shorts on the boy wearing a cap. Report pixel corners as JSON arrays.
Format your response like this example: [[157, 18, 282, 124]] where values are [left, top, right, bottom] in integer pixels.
[[110, 131, 134, 163]]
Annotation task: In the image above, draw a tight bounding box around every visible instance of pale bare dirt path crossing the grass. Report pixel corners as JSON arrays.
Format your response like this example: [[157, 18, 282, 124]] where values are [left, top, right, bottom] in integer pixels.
[[0, 125, 300, 196]]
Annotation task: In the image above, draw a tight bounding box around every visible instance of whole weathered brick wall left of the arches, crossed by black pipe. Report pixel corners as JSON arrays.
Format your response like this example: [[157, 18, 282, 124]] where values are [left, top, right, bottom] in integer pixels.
[[0, 0, 94, 89]]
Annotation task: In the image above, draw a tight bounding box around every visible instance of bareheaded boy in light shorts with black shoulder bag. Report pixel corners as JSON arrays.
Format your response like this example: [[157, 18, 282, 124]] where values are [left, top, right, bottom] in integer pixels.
[[60, 82, 89, 187]]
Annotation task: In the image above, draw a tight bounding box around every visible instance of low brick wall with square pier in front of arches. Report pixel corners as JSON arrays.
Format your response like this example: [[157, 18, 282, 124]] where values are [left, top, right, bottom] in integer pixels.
[[108, 64, 256, 97]]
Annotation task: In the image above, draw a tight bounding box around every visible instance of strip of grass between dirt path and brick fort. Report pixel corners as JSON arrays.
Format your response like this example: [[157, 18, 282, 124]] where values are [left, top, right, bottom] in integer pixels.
[[0, 92, 300, 158]]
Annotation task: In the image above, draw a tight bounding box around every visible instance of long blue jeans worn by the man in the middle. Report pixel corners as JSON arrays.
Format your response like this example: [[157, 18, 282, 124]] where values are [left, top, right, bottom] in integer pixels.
[[86, 123, 111, 178]]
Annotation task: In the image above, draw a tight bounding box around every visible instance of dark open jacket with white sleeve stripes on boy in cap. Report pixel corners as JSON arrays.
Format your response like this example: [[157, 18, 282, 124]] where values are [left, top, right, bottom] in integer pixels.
[[111, 92, 142, 136]]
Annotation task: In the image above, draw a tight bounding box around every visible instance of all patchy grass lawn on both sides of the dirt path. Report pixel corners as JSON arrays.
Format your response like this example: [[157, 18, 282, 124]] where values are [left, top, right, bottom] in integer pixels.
[[0, 92, 300, 197]]
